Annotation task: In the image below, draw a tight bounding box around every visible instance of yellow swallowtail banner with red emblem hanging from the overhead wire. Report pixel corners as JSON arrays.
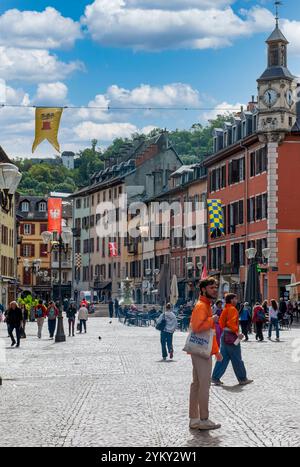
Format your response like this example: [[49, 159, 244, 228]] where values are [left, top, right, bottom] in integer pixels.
[[32, 107, 63, 153]]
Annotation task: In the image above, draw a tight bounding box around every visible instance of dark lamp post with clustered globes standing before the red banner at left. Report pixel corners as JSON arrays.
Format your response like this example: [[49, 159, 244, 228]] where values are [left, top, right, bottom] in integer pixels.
[[42, 229, 73, 342]]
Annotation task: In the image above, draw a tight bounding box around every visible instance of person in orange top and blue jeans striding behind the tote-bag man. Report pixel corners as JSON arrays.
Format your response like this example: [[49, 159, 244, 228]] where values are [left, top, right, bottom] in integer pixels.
[[212, 294, 253, 386]]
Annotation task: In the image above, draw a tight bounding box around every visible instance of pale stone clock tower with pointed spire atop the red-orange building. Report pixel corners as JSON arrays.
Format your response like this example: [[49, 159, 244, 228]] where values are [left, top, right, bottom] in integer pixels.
[[257, 14, 297, 141]]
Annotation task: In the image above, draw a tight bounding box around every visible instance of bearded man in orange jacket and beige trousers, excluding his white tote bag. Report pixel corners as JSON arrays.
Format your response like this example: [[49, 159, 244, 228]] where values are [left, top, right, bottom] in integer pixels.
[[189, 278, 222, 430]]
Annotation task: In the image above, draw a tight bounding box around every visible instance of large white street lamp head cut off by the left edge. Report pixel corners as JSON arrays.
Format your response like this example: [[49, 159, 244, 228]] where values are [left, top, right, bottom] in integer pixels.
[[0, 163, 22, 214]]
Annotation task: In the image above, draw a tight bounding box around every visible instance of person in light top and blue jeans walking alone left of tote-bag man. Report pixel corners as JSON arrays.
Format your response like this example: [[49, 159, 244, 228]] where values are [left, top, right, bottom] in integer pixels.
[[156, 303, 178, 361]]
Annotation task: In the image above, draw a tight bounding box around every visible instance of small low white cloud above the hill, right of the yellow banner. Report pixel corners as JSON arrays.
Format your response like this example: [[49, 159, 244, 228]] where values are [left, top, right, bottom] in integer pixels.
[[74, 122, 138, 142]]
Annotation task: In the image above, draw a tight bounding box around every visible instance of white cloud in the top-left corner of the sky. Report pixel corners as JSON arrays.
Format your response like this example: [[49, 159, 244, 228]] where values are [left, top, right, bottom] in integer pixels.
[[0, 7, 82, 49]]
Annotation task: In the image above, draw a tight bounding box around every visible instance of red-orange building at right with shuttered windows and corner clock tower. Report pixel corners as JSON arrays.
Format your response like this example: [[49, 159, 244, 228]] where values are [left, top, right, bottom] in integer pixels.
[[205, 25, 300, 300]]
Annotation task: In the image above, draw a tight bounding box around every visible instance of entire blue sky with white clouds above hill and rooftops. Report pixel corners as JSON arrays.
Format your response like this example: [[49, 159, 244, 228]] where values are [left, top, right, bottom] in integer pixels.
[[0, 0, 300, 157]]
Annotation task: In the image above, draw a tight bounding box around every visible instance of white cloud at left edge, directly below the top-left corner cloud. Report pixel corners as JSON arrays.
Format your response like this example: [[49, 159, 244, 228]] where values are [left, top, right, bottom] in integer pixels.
[[0, 46, 84, 82]]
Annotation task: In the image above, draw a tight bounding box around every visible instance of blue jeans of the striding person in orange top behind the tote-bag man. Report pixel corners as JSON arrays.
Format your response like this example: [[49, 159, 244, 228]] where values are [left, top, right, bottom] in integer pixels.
[[212, 335, 247, 382]]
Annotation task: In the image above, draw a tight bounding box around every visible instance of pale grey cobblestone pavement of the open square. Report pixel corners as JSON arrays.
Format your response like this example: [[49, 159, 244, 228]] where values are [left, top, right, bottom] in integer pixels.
[[0, 318, 300, 447]]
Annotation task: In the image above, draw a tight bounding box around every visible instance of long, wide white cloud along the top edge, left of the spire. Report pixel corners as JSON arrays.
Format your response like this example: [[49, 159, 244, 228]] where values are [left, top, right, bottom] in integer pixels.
[[82, 0, 274, 50]]
